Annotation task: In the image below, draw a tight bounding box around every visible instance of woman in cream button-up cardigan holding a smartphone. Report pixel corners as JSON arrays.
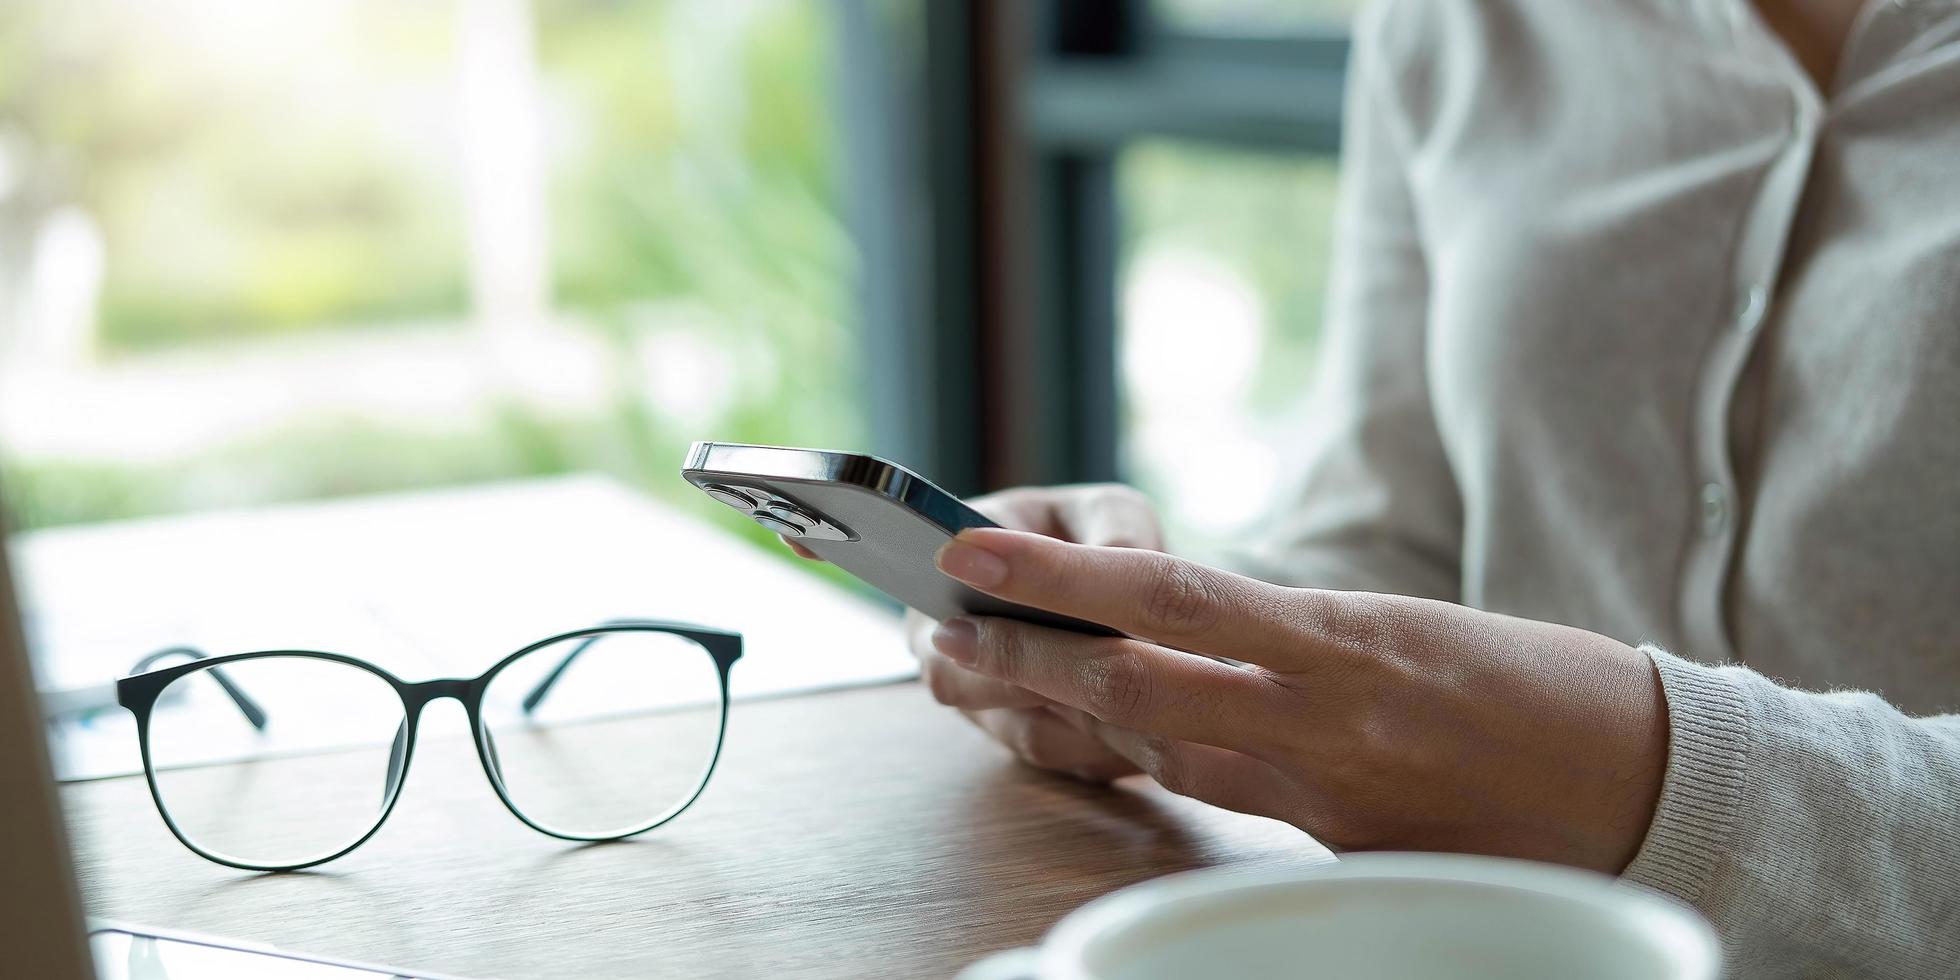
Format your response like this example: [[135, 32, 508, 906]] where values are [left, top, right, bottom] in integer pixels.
[[815, 0, 1960, 976]]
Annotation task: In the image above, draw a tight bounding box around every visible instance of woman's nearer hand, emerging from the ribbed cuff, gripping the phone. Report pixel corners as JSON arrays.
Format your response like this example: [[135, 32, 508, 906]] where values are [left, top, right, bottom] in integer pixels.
[[933, 529, 1668, 874]]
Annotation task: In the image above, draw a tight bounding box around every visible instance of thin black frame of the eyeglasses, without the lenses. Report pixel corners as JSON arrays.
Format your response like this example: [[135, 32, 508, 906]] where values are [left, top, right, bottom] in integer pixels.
[[116, 619, 743, 872]]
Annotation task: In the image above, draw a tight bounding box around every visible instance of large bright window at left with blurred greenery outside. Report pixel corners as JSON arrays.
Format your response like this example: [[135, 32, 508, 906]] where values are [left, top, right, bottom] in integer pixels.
[[0, 0, 862, 537]]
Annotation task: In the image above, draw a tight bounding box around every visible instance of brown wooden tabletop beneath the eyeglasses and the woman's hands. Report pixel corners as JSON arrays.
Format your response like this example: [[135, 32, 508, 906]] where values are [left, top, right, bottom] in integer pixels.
[[63, 684, 1331, 980]]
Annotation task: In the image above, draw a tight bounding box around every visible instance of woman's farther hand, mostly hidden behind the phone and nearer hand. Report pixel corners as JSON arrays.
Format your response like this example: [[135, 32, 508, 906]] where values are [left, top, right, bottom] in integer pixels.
[[784, 484, 1164, 782]]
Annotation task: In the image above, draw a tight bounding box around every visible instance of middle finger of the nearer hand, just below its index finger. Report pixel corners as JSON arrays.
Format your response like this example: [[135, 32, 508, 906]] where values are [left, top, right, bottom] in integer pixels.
[[933, 617, 1284, 751]]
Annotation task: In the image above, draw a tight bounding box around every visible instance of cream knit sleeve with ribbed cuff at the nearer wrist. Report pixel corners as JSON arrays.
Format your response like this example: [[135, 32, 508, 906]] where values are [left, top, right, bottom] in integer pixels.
[[1625, 647, 1960, 976]]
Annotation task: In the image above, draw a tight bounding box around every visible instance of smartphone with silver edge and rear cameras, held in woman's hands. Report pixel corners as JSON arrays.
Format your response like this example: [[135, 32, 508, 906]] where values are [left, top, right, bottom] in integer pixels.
[[680, 443, 1119, 637]]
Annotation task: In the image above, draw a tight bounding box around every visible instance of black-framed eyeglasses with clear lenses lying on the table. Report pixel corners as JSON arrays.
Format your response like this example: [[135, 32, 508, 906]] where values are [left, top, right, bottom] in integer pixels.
[[116, 619, 741, 870]]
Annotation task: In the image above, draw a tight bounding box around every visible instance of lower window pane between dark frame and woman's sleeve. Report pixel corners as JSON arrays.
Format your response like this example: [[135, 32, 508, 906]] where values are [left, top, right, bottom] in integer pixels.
[[1117, 141, 1335, 551]]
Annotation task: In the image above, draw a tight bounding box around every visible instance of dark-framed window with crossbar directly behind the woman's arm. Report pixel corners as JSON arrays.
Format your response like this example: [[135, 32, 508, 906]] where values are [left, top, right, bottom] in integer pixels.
[[1000, 0, 1356, 555]]
